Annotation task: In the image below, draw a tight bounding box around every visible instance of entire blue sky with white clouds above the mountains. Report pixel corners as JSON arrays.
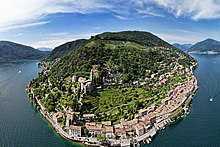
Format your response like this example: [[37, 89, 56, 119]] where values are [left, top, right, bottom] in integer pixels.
[[0, 0, 220, 48]]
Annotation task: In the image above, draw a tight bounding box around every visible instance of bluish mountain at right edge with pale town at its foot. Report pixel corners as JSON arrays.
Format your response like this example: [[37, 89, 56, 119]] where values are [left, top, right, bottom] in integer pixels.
[[187, 39, 220, 54]]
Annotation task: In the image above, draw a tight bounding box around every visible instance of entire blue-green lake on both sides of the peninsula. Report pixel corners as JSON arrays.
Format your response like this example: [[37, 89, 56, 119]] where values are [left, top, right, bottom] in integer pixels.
[[0, 55, 220, 147]]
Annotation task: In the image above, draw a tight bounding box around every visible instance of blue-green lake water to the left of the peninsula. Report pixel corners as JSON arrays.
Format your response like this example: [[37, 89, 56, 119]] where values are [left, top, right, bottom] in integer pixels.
[[0, 61, 82, 147]]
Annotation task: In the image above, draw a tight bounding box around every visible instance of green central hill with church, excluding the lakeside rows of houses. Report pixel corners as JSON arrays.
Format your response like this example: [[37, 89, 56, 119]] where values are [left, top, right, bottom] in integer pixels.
[[30, 31, 196, 123]]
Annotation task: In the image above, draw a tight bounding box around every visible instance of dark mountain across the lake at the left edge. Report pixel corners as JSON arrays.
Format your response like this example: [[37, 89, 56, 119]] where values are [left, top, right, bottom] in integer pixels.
[[0, 41, 47, 62]]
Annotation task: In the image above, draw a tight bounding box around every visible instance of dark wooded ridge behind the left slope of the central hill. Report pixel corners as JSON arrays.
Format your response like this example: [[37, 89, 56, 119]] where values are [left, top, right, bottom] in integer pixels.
[[43, 39, 86, 61]]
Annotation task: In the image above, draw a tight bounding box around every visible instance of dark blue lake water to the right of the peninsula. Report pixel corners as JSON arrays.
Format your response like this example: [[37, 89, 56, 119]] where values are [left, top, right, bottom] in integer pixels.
[[144, 55, 220, 147]]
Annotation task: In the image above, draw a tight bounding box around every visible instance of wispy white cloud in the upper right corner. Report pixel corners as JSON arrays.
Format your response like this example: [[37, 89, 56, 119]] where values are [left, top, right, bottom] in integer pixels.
[[134, 0, 220, 20]]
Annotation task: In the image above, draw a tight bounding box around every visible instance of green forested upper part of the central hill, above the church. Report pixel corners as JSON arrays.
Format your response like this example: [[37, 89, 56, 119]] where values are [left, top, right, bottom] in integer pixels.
[[47, 31, 194, 78]]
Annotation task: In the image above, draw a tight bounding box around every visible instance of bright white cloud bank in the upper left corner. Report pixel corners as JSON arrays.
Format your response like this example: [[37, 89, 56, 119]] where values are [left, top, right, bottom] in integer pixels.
[[0, 0, 108, 30]]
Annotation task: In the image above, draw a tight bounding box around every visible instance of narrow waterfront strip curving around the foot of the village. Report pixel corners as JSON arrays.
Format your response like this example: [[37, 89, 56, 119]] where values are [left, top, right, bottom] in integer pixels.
[[26, 72, 198, 146]]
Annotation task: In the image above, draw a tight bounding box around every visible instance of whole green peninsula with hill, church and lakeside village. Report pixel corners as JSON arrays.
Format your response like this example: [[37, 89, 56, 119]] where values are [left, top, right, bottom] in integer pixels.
[[27, 31, 198, 146]]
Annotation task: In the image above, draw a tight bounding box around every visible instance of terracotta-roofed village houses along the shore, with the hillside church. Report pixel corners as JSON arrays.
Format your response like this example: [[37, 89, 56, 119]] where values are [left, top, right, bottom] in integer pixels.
[[27, 60, 198, 145]]
